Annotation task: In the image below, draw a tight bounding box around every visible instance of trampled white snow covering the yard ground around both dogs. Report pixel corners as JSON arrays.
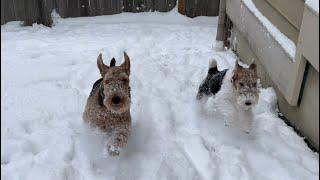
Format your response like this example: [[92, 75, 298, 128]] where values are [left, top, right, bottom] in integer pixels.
[[1, 10, 319, 180]]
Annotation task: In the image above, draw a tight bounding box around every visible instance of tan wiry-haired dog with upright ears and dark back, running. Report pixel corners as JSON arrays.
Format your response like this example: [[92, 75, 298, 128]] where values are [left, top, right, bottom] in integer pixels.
[[83, 53, 131, 155]]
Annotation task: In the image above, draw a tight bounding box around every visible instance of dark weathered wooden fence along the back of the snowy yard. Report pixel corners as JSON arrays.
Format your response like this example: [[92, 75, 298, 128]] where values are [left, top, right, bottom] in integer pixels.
[[1, 0, 220, 26]]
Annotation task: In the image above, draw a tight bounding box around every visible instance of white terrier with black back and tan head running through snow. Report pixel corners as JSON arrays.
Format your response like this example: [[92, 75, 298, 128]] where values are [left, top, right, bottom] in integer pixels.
[[197, 59, 260, 133]]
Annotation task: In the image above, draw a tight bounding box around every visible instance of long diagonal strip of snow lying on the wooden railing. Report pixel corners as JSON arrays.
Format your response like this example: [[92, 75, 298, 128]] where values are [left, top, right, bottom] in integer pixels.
[[242, 0, 296, 61]]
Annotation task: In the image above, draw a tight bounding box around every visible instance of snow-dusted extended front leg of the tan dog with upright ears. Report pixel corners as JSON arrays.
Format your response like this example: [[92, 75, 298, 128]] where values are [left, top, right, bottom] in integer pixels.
[[107, 123, 131, 156]]
